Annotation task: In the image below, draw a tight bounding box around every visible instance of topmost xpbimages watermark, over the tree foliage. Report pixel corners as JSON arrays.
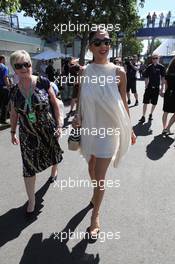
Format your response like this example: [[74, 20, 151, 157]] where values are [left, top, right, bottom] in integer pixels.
[[54, 21, 120, 35]]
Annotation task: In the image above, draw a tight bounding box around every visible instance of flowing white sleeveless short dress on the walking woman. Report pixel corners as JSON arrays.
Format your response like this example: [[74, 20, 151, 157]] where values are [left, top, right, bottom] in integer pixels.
[[80, 63, 131, 167]]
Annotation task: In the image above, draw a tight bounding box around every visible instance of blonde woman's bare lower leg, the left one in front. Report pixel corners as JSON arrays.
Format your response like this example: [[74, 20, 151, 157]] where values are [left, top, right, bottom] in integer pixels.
[[24, 175, 36, 212]]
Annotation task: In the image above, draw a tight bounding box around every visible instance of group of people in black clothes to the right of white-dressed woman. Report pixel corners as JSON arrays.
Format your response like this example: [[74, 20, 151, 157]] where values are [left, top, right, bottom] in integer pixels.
[[114, 54, 175, 135]]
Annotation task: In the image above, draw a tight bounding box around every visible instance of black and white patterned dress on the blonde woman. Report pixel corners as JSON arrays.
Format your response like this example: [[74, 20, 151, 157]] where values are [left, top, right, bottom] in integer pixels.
[[11, 77, 63, 177]]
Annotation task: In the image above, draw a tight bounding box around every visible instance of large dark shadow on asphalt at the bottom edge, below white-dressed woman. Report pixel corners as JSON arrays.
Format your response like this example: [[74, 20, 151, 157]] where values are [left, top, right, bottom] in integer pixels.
[[19, 206, 100, 264]]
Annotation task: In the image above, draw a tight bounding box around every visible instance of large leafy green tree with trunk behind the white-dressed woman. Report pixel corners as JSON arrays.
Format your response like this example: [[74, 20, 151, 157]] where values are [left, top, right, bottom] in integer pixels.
[[20, 0, 144, 63]]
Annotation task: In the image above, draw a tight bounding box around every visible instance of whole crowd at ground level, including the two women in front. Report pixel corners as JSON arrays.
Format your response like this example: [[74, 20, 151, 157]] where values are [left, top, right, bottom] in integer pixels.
[[0, 26, 175, 239]]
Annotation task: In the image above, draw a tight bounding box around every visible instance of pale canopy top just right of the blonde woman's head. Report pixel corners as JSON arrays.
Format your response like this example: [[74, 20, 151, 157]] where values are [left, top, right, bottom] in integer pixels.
[[32, 50, 70, 60]]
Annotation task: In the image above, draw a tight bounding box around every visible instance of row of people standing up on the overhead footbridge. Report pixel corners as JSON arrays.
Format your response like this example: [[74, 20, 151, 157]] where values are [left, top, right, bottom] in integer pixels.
[[146, 11, 171, 28]]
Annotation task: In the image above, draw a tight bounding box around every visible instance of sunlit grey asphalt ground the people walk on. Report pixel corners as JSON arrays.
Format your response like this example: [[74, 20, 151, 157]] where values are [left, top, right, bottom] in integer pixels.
[[0, 81, 175, 264]]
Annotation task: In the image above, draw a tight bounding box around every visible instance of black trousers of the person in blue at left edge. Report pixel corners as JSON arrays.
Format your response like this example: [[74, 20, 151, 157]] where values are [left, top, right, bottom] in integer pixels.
[[0, 87, 9, 122]]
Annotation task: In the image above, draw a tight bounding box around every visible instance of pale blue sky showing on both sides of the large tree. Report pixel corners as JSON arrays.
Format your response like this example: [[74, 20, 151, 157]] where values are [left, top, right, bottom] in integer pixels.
[[18, 0, 175, 27]]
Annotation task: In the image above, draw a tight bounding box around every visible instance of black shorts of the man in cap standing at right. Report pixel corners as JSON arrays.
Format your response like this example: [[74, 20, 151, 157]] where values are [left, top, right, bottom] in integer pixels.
[[143, 87, 159, 105]]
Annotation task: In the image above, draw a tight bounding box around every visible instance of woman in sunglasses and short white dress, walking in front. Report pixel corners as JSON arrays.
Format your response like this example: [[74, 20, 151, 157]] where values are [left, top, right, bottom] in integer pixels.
[[73, 30, 136, 238]]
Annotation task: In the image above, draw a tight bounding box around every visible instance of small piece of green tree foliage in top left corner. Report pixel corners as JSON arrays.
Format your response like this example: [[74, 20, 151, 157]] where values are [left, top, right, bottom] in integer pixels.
[[0, 0, 20, 14]]
